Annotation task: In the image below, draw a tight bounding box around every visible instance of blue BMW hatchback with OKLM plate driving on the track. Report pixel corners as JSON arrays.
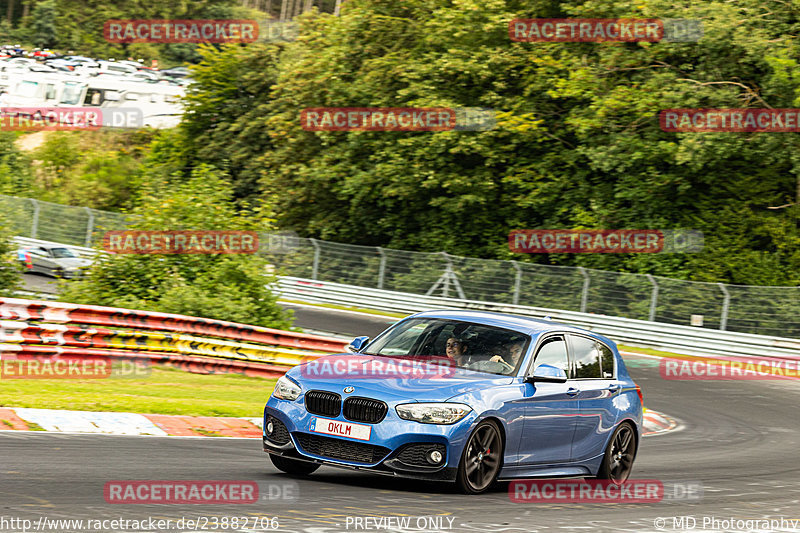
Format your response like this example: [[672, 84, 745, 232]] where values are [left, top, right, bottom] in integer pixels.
[[263, 311, 642, 494]]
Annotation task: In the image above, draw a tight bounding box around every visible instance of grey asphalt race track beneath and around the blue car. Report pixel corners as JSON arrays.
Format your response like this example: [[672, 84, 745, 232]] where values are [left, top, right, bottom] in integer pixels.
[[0, 300, 800, 533]]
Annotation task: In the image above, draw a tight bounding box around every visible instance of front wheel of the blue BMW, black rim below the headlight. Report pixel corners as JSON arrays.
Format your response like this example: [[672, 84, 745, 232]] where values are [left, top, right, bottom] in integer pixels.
[[456, 420, 504, 494]]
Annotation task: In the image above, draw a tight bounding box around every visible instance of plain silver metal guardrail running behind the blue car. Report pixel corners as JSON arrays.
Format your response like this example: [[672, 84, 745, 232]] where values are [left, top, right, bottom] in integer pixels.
[[278, 276, 800, 359]]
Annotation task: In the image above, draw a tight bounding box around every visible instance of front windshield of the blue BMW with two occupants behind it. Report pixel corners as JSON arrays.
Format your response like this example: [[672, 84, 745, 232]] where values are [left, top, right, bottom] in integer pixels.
[[367, 318, 530, 375]]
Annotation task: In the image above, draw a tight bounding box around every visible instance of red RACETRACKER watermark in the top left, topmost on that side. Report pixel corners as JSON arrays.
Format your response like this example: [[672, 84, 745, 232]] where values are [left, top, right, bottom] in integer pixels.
[[103, 19, 258, 43]]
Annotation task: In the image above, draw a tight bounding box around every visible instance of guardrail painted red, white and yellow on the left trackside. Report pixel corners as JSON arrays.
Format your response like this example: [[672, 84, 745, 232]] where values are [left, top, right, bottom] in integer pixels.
[[0, 298, 346, 376]]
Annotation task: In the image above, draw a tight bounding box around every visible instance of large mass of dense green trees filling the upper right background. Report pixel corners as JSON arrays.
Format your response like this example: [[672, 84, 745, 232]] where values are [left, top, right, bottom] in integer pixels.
[[173, 0, 800, 284]]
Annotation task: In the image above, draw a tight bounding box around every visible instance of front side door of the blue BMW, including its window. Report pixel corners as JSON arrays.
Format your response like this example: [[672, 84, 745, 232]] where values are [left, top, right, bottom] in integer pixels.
[[519, 334, 579, 465]]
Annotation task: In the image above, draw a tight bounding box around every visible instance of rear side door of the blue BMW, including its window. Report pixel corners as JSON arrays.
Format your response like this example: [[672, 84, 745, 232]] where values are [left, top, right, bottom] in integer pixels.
[[567, 333, 620, 461]]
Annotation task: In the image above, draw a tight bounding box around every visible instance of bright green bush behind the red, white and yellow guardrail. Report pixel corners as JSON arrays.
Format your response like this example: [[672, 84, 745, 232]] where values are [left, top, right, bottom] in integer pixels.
[[61, 166, 291, 328]]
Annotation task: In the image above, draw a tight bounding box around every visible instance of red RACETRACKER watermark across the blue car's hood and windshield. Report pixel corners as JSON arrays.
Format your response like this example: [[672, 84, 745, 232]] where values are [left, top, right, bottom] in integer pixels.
[[300, 355, 456, 380]]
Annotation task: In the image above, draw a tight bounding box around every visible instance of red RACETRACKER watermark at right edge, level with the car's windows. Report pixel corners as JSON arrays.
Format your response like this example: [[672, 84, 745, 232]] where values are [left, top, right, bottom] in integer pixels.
[[658, 359, 800, 381]]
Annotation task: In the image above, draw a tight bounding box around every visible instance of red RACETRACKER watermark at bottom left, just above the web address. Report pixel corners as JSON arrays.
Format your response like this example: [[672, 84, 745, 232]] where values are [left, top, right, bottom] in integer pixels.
[[103, 481, 259, 504]]
